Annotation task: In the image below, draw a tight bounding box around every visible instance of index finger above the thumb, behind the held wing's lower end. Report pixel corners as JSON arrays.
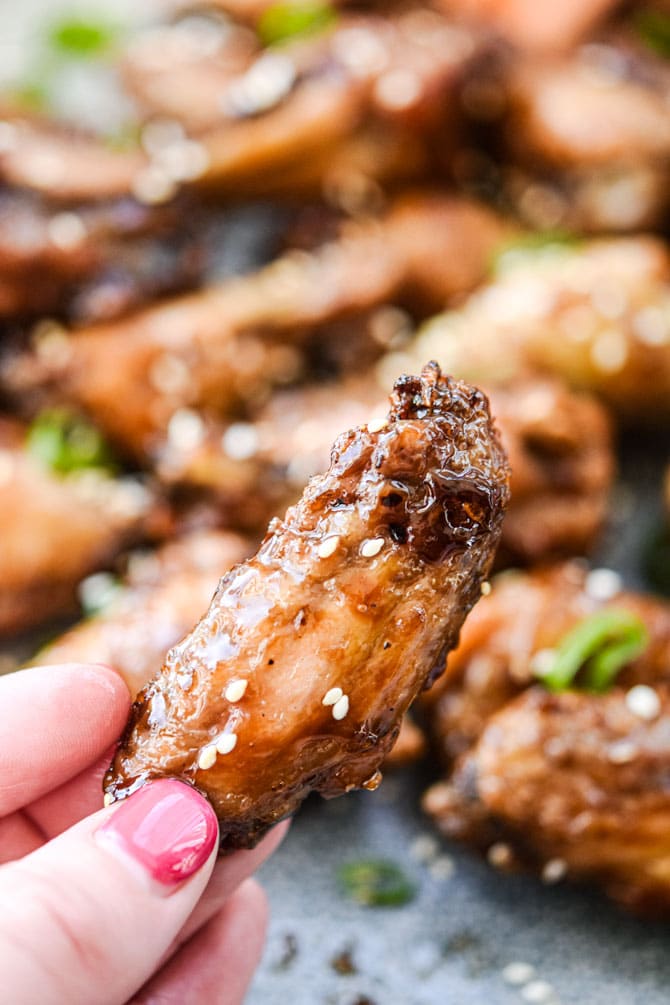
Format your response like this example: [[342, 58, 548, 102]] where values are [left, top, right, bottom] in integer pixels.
[[0, 663, 131, 816]]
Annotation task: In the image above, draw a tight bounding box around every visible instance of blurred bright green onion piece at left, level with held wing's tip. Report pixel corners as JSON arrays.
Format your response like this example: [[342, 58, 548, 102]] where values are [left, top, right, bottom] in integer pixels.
[[26, 408, 115, 474]]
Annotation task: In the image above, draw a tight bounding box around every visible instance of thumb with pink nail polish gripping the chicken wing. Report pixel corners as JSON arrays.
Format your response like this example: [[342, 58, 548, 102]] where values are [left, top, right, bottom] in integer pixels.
[[0, 780, 218, 1005]]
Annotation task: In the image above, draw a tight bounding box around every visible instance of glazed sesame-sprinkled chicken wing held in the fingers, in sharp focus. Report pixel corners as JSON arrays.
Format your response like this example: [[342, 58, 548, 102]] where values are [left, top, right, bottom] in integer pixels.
[[105, 364, 508, 848]]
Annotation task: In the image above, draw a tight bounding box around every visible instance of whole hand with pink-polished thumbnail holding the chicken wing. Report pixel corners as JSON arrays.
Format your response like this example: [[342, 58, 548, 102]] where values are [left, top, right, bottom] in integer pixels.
[[0, 664, 285, 1005]]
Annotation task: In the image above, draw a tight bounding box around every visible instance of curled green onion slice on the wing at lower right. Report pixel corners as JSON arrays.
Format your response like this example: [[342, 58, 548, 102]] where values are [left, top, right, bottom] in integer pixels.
[[538, 609, 649, 693]]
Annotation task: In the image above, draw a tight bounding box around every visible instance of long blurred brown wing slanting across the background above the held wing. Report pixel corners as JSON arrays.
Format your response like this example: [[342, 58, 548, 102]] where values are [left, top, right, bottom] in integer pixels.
[[2, 194, 505, 460]]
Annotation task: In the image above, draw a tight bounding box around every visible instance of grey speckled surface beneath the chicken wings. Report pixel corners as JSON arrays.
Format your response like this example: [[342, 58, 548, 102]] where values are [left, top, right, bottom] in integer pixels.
[[248, 434, 670, 1005]]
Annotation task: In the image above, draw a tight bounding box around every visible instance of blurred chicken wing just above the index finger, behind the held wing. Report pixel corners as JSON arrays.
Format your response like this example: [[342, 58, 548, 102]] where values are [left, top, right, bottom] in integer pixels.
[[31, 532, 250, 695]]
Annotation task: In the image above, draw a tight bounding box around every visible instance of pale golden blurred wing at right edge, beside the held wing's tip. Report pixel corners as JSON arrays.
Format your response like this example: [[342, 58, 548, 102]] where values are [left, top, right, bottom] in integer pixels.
[[389, 236, 670, 424]]
